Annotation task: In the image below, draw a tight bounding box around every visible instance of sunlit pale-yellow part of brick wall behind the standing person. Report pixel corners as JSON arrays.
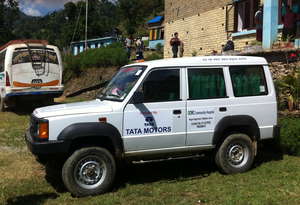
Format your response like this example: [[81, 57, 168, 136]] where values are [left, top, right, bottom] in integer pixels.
[[164, 7, 227, 58]]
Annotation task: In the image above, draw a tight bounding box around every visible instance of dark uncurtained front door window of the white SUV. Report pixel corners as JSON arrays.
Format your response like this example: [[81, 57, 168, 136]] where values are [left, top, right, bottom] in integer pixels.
[[142, 69, 180, 102]]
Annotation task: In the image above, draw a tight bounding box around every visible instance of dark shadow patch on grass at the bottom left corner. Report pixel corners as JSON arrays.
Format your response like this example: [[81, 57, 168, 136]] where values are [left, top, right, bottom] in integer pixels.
[[6, 193, 58, 205]]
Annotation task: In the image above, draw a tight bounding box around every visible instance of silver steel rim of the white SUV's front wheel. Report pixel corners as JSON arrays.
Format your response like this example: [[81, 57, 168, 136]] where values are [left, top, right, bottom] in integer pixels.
[[74, 156, 107, 189]]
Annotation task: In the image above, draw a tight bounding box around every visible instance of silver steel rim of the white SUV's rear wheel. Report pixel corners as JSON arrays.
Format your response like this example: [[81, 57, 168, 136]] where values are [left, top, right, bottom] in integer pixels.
[[227, 144, 249, 167]]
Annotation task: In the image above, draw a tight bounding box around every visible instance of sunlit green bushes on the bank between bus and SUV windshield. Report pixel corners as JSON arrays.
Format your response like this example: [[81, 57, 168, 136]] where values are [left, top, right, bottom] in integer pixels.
[[64, 46, 128, 81]]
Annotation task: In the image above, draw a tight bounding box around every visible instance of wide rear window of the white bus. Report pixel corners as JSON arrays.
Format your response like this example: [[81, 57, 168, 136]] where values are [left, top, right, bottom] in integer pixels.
[[12, 48, 58, 65]]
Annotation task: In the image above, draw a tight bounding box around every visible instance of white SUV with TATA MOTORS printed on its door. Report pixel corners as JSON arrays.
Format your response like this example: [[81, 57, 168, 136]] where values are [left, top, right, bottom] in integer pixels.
[[26, 56, 279, 196]]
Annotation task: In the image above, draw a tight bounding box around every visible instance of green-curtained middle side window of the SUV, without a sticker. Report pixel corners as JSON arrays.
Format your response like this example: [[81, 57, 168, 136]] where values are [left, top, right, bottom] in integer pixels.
[[188, 68, 226, 100]]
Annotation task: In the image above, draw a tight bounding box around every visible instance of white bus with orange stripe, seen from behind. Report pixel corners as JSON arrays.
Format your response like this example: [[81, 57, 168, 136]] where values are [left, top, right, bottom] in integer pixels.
[[0, 40, 63, 111]]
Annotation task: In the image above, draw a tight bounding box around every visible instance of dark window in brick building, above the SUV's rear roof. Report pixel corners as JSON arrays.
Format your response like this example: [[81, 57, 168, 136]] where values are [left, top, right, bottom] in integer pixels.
[[235, 0, 260, 32]]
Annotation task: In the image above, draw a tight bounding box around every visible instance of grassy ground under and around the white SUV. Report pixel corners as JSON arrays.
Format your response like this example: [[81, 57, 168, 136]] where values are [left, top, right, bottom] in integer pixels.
[[0, 105, 300, 205]]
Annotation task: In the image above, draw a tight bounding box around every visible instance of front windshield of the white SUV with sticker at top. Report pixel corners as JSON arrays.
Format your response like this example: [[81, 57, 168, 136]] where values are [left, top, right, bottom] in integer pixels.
[[100, 66, 146, 101]]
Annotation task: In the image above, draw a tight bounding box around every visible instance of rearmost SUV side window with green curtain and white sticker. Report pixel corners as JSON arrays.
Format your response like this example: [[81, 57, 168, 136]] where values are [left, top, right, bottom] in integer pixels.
[[229, 65, 268, 97]]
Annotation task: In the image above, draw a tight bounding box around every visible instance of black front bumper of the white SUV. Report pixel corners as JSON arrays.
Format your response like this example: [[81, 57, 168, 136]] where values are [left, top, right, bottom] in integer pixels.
[[25, 130, 70, 155]]
